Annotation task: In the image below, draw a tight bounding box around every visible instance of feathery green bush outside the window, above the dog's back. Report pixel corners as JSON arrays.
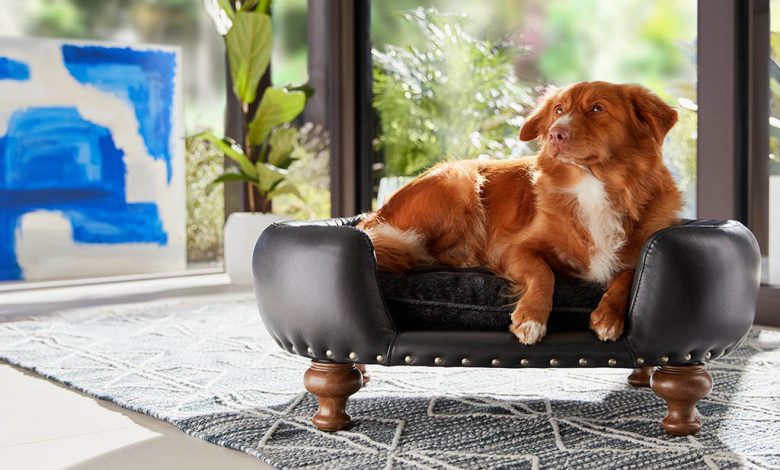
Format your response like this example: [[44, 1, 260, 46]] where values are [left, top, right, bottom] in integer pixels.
[[373, 8, 533, 176]]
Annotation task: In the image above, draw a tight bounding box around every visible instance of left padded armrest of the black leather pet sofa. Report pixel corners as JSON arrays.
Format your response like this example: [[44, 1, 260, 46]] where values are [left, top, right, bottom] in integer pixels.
[[252, 218, 396, 363]]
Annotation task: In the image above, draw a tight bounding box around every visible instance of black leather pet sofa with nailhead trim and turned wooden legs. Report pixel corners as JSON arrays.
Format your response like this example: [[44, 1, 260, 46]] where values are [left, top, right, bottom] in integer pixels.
[[253, 217, 760, 435]]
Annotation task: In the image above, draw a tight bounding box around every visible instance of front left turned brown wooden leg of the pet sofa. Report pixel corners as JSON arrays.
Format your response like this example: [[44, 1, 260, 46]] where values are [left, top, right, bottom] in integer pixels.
[[303, 361, 363, 432]]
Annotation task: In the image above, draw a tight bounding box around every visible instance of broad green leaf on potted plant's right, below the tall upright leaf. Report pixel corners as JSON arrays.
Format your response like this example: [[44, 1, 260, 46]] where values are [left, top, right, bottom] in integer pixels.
[[249, 88, 306, 145]]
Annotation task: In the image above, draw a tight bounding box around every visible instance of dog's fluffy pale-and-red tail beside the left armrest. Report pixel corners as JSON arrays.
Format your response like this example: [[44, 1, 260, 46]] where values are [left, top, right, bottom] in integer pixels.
[[358, 217, 435, 273]]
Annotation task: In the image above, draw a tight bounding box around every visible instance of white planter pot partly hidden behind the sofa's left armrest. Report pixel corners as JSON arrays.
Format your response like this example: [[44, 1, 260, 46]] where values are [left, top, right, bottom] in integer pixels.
[[223, 212, 286, 285]]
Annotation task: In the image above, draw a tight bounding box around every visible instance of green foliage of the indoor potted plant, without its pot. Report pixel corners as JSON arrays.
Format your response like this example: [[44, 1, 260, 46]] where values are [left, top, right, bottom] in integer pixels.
[[198, 0, 306, 212]]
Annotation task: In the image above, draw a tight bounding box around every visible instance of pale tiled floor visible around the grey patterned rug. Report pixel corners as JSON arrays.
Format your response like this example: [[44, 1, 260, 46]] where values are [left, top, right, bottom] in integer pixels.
[[0, 275, 272, 470]]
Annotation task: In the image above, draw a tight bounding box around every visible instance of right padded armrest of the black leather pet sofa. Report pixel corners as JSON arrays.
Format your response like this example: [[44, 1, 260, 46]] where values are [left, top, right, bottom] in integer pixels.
[[625, 220, 761, 365]]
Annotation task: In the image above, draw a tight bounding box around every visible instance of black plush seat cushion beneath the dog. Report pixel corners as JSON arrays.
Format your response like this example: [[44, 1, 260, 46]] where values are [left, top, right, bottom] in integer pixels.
[[378, 267, 604, 331]]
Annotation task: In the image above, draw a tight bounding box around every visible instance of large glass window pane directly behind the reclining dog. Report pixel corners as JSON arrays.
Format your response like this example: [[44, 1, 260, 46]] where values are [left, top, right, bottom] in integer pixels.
[[371, 0, 697, 217]]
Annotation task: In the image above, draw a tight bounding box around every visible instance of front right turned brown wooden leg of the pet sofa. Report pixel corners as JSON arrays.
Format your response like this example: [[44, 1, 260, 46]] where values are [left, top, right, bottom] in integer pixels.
[[650, 364, 712, 436]]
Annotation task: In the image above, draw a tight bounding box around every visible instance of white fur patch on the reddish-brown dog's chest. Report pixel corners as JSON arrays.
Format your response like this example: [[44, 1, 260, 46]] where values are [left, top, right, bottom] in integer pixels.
[[569, 173, 625, 283]]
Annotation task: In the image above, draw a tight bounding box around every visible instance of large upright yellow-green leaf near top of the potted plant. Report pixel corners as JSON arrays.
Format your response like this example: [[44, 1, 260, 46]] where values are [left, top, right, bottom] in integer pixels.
[[225, 11, 271, 103]]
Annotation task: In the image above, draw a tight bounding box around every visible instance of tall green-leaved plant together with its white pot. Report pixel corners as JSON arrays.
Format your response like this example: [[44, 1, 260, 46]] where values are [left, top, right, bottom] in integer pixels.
[[198, 0, 307, 284]]
